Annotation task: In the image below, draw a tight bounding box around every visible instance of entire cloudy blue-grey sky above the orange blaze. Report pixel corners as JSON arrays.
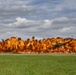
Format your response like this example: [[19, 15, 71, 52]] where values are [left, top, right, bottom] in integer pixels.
[[0, 0, 76, 40]]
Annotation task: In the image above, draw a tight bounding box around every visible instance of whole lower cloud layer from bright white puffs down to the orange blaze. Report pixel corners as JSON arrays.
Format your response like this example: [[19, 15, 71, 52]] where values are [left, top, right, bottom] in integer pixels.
[[0, 17, 76, 39]]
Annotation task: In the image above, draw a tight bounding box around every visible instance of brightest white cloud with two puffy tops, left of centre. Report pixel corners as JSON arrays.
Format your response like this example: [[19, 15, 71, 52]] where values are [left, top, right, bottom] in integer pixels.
[[8, 17, 53, 28]]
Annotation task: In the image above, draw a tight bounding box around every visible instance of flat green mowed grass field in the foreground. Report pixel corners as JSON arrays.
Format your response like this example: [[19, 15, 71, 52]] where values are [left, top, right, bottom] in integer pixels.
[[0, 54, 76, 75]]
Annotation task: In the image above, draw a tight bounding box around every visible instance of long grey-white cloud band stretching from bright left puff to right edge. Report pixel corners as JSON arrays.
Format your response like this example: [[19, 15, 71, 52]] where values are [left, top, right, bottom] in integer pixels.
[[8, 17, 76, 30]]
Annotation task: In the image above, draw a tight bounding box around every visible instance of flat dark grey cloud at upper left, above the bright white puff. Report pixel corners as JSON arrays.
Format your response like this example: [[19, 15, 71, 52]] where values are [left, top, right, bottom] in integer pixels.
[[0, 5, 47, 19]]
